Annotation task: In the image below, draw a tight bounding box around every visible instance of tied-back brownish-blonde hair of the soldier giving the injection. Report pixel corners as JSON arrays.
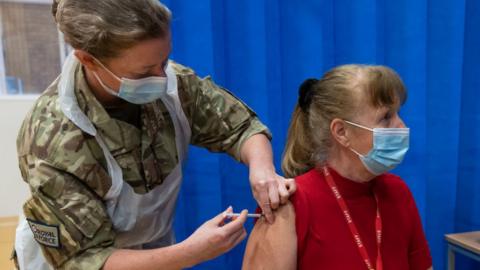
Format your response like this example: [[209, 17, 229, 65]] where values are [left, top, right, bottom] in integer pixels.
[[52, 0, 171, 59]]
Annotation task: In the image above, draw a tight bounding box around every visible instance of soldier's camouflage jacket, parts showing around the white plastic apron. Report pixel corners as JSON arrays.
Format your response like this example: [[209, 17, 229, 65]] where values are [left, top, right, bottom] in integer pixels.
[[17, 63, 270, 269]]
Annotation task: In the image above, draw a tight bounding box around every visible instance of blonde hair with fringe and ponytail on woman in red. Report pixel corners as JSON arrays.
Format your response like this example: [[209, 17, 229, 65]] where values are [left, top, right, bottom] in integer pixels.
[[282, 65, 407, 177]]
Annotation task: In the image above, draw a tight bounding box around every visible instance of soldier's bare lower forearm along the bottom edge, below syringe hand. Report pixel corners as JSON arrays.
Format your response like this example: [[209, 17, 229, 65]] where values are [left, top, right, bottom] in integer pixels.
[[103, 242, 199, 270]]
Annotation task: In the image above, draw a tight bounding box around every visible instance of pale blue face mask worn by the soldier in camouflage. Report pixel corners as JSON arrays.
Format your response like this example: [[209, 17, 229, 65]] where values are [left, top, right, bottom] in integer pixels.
[[93, 60, 167, 104]]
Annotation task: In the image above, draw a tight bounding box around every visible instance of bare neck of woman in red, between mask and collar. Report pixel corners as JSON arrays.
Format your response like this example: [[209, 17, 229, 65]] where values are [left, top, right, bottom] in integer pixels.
[[327, 148, 375, 183]]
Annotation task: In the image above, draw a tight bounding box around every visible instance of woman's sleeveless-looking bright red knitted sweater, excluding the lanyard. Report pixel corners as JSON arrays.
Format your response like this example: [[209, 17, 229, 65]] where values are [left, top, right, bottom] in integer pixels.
[[291, 168, 432, 270]]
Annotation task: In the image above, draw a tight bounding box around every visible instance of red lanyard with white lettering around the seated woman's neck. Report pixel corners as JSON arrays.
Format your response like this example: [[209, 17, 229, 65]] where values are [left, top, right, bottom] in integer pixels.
[[323, 166, 383, 270]]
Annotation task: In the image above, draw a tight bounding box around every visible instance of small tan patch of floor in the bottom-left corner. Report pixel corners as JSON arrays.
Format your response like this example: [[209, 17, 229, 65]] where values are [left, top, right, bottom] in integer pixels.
[[0, 217, 18, 270]]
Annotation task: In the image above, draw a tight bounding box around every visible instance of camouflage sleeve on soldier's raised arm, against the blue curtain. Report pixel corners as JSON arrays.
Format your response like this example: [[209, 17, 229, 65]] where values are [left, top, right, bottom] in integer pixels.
[[180, 73, 271, 161]]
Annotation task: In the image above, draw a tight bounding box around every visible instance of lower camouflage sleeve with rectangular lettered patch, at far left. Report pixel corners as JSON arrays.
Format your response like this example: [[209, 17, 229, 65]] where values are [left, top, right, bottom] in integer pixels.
[[21, 156, 115, 269]]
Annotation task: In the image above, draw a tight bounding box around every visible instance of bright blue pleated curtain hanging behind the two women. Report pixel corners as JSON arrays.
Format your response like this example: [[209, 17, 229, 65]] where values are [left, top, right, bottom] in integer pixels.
[[164, 0, 480, 269]]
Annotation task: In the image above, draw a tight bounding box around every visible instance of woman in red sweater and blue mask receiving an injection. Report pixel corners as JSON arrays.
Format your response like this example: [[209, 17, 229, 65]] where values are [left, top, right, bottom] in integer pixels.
[[243, 65, 432, 270]]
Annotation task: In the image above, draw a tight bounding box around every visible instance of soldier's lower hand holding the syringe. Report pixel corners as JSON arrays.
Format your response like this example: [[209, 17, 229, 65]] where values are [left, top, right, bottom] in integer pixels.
[[182, 207, 248, 264]]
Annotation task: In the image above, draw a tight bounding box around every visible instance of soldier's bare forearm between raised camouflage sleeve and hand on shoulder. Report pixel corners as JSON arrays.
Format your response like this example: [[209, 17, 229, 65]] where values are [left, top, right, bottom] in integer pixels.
[[241, 134, 275, 171]]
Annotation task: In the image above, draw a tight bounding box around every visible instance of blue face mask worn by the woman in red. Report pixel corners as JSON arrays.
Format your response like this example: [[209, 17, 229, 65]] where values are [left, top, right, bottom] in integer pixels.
[[345, 120, 410, 175]]
